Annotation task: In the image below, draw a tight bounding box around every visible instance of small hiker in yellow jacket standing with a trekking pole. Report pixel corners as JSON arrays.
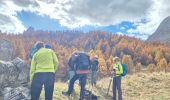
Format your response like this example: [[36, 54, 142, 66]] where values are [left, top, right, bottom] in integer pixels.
[[112, 57, 123, 100]]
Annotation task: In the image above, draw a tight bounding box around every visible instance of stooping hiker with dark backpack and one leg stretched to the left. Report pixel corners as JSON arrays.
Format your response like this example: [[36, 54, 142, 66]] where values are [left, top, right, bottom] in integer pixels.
[[62, 52, 90, 100]]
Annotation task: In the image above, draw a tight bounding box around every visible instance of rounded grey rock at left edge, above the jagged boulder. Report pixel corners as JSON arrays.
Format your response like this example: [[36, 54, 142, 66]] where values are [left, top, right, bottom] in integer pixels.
[[0, 39, 14, 61]]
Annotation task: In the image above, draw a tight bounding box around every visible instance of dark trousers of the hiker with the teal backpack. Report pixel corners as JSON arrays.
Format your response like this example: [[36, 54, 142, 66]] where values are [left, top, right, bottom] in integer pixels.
[[113, 76, 122, 100]]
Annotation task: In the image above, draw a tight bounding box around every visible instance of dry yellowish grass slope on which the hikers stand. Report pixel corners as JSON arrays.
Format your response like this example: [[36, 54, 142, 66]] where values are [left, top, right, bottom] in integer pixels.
[[42, 73, 170, 100]]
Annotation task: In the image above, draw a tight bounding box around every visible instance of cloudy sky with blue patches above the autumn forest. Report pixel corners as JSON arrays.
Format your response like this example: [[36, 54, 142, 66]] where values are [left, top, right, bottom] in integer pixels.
[[0, 0, 170, 39]]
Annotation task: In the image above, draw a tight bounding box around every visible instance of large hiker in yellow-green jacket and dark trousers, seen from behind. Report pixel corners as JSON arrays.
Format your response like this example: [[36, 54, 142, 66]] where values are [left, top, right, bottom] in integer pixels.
[[30, 42, 59, 100]]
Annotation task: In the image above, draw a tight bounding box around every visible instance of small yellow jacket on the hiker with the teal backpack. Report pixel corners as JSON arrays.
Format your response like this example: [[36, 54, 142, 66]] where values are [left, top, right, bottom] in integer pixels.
[[113, 62, 123, 76]]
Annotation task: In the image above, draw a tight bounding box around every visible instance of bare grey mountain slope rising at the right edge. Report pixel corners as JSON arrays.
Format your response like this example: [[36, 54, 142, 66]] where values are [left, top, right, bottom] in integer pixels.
[[147, 16, 170, 43]]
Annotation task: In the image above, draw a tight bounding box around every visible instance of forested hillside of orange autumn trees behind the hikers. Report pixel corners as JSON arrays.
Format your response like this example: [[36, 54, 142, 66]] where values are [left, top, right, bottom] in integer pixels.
[[0, 29, 170, 75]]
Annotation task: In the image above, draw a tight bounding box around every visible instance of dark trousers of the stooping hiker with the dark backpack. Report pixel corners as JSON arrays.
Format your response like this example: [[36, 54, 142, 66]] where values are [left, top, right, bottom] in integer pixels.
[[68, 74, 87, 100]]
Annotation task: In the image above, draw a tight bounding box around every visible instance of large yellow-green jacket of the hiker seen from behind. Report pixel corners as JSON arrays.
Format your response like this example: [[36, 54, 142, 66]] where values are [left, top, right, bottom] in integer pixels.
[[30, 48, 59, 81]]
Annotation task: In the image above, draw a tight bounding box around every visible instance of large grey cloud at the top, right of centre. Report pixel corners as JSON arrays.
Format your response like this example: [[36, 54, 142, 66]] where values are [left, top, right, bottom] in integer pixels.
[[67, 0, 152, 24]]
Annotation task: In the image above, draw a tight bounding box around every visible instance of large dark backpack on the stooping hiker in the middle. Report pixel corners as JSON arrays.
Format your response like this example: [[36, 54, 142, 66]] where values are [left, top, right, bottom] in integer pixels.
[[77, 52, 90, 70]]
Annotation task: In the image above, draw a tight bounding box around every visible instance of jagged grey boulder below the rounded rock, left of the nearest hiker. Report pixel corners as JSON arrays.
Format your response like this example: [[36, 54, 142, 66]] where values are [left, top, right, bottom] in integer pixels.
[[0, 58, 29, 94]]
